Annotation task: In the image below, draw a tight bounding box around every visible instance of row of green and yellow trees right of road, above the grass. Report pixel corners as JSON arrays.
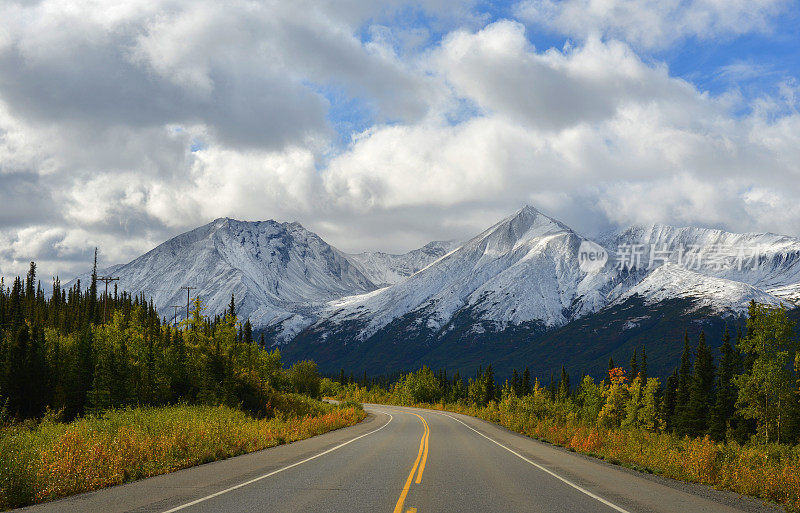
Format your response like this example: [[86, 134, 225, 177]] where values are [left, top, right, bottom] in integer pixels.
[[339, 302, 800, 443]]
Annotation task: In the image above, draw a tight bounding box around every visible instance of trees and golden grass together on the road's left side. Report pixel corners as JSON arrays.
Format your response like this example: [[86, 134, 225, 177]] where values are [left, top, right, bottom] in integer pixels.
[[0, 263, 366, 509]]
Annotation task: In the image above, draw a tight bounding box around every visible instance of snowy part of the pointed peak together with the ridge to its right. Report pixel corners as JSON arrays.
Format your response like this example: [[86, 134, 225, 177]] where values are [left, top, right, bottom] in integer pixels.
[[288, 206, 800, 370]]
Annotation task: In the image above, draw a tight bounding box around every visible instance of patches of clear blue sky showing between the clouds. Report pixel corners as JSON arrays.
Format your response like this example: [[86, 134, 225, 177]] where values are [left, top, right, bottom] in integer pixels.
[[324, 1, 800, 147]]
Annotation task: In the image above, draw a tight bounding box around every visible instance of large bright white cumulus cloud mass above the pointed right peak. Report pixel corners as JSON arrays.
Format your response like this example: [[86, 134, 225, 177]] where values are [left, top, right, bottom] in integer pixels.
[[324, 22, 800, 235]]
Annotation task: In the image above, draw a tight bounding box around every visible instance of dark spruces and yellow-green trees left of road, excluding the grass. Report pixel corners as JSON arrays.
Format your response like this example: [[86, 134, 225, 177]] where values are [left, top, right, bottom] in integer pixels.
[[0, 258, 320, 422]]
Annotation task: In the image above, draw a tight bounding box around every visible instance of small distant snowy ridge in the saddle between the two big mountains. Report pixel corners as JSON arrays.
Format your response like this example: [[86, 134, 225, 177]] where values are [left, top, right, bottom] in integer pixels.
[[347, 240, 461, 287]]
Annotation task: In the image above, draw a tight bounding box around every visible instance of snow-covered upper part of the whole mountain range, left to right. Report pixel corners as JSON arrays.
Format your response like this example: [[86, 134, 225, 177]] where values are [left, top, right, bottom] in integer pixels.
[[70, 205, 800, 341]]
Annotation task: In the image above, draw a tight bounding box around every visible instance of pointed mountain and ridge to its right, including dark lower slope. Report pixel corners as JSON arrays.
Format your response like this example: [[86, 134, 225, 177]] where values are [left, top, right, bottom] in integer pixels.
[[284, 207, 800, 374]]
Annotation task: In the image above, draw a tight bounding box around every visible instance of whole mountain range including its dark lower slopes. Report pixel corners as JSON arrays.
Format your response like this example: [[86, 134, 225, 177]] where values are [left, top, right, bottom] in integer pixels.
[[70, 206, 800, 374]]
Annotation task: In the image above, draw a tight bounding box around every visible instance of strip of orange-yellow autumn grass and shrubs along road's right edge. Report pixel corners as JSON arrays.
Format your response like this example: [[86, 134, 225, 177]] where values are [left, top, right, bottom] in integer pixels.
[[341, 393, 800, 511]]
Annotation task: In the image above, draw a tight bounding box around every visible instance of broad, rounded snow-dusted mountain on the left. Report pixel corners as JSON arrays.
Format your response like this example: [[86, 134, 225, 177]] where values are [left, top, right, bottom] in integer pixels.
[[68, 218, 376, 326]]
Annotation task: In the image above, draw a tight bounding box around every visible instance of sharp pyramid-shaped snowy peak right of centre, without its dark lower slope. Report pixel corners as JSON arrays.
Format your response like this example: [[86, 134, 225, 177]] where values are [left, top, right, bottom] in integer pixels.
[[306, 206, 621, 340]]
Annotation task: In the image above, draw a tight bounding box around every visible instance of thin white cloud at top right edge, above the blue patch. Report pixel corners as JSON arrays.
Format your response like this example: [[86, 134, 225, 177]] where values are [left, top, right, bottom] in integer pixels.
[[515, 0, 792, 49]]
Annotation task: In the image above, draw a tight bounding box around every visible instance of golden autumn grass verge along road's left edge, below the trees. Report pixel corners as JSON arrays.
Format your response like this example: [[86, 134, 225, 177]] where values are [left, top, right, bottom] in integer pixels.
[[0, 394, 366, 509]]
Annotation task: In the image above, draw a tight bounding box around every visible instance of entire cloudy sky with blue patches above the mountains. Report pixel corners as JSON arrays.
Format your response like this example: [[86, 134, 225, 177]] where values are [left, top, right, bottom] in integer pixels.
[[0, 0, 800, 280]]
